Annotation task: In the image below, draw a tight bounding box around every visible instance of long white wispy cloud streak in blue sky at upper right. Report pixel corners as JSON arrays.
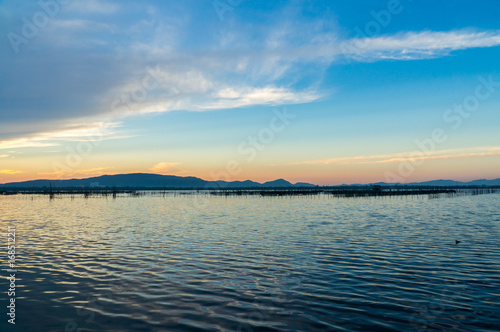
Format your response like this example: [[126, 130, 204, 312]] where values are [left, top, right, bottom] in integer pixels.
[[254, 29, 500, 64]]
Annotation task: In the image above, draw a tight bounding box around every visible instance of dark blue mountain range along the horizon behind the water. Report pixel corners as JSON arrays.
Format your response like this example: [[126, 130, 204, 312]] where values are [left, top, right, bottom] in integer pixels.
[[0, 173, 500, 189]]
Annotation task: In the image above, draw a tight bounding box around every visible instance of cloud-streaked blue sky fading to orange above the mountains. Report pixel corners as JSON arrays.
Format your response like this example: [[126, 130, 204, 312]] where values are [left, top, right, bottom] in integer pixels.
[[0, 0, 500, 185]]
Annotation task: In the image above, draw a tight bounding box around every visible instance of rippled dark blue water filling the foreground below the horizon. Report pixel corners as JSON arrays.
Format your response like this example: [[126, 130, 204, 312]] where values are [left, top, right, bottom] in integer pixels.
[[0, 194, 500, 332]]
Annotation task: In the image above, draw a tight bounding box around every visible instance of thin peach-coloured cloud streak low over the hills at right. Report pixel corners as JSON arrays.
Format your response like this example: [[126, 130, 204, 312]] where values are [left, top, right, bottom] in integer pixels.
[[285, 147, 500, 165]]
